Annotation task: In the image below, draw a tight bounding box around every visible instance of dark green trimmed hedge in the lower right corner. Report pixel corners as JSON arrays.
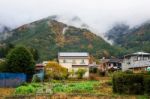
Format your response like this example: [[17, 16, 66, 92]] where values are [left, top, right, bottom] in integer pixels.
[[112, 73, 150, 95]]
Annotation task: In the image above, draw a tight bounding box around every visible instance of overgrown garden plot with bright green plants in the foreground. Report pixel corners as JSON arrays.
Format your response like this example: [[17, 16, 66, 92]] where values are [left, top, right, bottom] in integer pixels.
[[0, 77, 148, 99]]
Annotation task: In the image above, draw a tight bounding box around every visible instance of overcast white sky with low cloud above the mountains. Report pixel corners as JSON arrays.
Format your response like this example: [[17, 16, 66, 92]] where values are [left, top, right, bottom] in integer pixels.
[[0, 0, 150, 34]]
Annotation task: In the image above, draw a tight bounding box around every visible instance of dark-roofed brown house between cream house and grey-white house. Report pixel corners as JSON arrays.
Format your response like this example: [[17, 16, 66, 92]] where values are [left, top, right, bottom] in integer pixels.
[[99, 58, 122, 71]]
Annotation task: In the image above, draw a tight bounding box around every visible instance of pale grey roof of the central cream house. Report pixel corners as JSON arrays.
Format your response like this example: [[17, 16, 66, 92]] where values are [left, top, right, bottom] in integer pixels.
[[58, 52, 89, 57]]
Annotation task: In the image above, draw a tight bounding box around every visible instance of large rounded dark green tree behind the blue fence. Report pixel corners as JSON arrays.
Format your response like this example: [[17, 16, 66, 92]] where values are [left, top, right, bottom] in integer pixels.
[[6, 46, 35, 75]]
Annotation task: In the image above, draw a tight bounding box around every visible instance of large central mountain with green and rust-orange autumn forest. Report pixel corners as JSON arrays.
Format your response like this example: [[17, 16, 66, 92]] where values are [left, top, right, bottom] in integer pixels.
[[1, 16, 120, 60]]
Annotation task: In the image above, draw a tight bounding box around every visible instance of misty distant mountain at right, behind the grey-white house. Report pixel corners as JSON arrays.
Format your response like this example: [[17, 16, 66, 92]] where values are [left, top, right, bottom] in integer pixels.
[[106, 22, 150, 52]]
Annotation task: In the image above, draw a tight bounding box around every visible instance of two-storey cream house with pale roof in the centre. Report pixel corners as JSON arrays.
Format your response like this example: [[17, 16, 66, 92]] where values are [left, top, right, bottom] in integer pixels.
[[58, 52, 89, 78]]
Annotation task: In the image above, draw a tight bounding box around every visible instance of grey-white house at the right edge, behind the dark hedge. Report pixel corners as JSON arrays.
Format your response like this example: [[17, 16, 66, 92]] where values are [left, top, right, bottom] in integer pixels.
[[122, 52, 150, 73]]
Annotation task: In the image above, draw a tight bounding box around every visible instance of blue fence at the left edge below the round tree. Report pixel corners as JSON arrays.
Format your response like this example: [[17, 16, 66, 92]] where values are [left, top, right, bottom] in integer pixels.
[[0, 73, 26, 87]]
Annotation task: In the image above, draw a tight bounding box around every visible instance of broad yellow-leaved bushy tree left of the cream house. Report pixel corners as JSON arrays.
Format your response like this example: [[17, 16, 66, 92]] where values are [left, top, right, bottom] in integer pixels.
[[45, 61, 68, 80]]
